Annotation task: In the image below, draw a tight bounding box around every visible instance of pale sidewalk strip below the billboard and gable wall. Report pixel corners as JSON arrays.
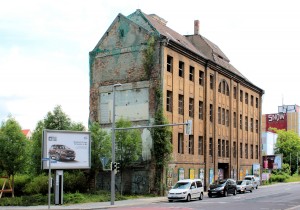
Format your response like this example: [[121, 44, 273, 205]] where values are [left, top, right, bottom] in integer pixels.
[[0, 197, 168, 210]]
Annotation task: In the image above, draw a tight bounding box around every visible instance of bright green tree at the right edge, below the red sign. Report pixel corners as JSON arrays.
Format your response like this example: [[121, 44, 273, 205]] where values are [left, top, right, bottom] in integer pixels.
[[274, 129, 300, 173]]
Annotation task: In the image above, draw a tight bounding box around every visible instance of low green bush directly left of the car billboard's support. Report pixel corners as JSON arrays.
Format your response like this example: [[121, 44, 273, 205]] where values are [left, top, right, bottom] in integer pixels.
[[24, 174, 48, 195]]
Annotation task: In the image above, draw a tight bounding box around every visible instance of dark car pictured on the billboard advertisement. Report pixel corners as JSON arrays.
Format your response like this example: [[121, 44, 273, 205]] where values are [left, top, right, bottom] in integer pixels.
[[49, 144, 76, 160]]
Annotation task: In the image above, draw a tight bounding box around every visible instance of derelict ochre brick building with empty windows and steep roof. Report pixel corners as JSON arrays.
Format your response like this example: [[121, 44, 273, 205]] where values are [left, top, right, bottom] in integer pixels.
[[90, 10, 264, 192]]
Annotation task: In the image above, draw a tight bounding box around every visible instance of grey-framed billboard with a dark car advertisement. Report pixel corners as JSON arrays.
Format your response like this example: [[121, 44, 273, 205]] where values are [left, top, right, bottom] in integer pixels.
[[42, 130, 91, 169]]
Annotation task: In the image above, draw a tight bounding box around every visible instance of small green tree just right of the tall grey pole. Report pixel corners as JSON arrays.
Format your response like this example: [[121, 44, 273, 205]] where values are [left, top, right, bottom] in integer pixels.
[[115, 118, 142, 193]]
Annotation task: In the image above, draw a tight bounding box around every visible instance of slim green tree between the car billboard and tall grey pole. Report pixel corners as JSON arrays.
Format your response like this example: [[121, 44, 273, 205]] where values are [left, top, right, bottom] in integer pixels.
[[89, 122, 111, 189]]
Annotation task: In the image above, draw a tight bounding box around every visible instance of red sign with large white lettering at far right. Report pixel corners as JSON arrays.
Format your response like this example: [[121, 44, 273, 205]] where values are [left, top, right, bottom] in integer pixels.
[[266, 113, 287, 131]]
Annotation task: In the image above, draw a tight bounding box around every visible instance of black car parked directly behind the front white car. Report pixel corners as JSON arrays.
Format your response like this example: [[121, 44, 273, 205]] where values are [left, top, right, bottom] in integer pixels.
[[208, 179, 237, 198]]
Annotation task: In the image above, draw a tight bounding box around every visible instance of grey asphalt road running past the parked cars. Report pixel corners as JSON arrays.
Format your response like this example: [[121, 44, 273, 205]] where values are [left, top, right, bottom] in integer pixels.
[[115, 183, 300, 210]]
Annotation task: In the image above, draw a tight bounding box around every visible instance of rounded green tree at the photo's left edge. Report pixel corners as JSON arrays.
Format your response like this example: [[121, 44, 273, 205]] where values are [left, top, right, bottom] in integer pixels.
[[0, 116, 27, 197]]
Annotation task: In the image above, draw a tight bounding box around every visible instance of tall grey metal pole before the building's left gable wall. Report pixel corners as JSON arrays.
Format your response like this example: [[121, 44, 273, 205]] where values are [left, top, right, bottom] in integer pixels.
[[110, 84, 121, 205]]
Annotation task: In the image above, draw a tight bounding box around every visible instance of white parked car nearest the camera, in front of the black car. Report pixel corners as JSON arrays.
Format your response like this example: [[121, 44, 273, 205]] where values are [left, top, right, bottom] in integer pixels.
[[168, 179, 204, 202]]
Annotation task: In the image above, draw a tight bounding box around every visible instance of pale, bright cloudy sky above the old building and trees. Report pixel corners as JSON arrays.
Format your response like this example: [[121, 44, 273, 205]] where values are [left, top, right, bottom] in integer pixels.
[[0, 0, 300, 131]]
